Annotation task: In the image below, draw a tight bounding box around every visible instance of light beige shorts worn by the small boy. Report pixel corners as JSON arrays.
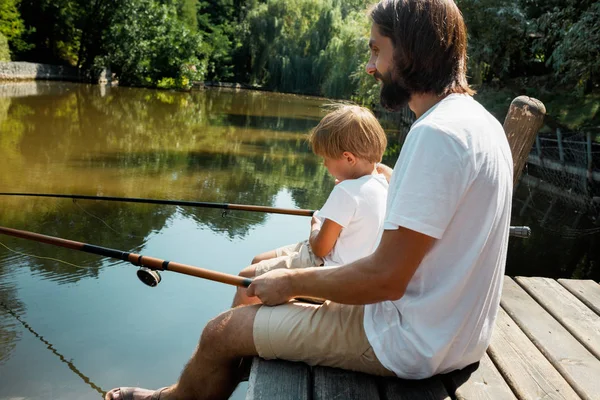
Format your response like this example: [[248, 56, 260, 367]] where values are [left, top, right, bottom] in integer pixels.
[[254, 240, 323, 276]]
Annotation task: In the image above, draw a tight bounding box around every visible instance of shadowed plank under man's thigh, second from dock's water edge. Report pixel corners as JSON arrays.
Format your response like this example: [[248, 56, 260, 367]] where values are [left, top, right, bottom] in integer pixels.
[[314, 366, 379, 400]]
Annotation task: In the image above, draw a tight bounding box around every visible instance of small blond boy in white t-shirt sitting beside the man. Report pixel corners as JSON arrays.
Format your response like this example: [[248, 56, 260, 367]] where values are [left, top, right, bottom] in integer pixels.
[[233, 105, 388, 306]]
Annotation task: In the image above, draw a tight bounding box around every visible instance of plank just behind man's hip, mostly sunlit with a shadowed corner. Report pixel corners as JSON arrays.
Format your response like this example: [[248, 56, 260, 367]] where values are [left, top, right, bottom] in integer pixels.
[[445, 354, 516, 400]]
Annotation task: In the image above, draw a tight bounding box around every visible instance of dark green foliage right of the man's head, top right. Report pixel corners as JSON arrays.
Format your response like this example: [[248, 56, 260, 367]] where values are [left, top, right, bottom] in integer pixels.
[[457, 0, 600, 93]]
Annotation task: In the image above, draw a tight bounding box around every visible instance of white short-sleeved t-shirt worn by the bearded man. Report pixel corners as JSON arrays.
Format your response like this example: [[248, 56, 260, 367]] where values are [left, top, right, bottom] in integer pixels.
[[364, 94, 513, 379]]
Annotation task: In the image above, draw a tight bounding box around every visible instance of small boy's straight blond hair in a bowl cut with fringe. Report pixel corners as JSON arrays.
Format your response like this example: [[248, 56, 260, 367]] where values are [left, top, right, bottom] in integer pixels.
[[308, 105, 387, 163]]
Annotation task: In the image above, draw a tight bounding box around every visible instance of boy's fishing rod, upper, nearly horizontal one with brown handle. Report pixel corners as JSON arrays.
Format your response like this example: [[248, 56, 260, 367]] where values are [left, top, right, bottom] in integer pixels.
[[0, 193, 315, 217]]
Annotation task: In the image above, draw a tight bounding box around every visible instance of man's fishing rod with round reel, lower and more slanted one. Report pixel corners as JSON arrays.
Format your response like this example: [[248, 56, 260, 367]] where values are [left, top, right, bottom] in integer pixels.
[[0, 226, 252, 287]]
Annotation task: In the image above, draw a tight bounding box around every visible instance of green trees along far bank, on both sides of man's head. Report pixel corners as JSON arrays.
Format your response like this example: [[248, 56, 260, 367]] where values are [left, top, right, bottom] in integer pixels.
[[0, 0, 600, 97]]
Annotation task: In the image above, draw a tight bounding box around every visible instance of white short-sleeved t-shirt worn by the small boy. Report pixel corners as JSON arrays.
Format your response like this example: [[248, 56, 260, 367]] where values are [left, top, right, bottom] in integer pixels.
[[317, 174, 388, 266]]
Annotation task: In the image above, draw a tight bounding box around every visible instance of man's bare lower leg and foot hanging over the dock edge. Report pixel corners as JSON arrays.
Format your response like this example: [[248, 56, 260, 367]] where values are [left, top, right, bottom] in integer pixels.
[[105, 306, 259, 400]]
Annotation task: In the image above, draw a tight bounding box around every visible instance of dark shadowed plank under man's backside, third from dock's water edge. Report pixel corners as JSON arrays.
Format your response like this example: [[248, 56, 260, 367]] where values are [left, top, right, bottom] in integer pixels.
[[379, 376, 451, 400]]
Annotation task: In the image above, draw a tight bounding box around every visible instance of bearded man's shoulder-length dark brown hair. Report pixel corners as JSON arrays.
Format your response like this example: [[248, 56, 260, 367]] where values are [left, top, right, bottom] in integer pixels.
[[370, 0, 475, 96]]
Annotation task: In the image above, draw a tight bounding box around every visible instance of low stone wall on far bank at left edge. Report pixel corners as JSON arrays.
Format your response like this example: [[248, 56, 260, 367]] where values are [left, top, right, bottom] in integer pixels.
[[0, 62, 81, 81]]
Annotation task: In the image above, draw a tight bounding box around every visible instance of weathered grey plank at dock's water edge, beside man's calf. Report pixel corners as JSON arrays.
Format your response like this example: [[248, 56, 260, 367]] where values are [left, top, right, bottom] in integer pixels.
[[246, 357, 310, 400]]
